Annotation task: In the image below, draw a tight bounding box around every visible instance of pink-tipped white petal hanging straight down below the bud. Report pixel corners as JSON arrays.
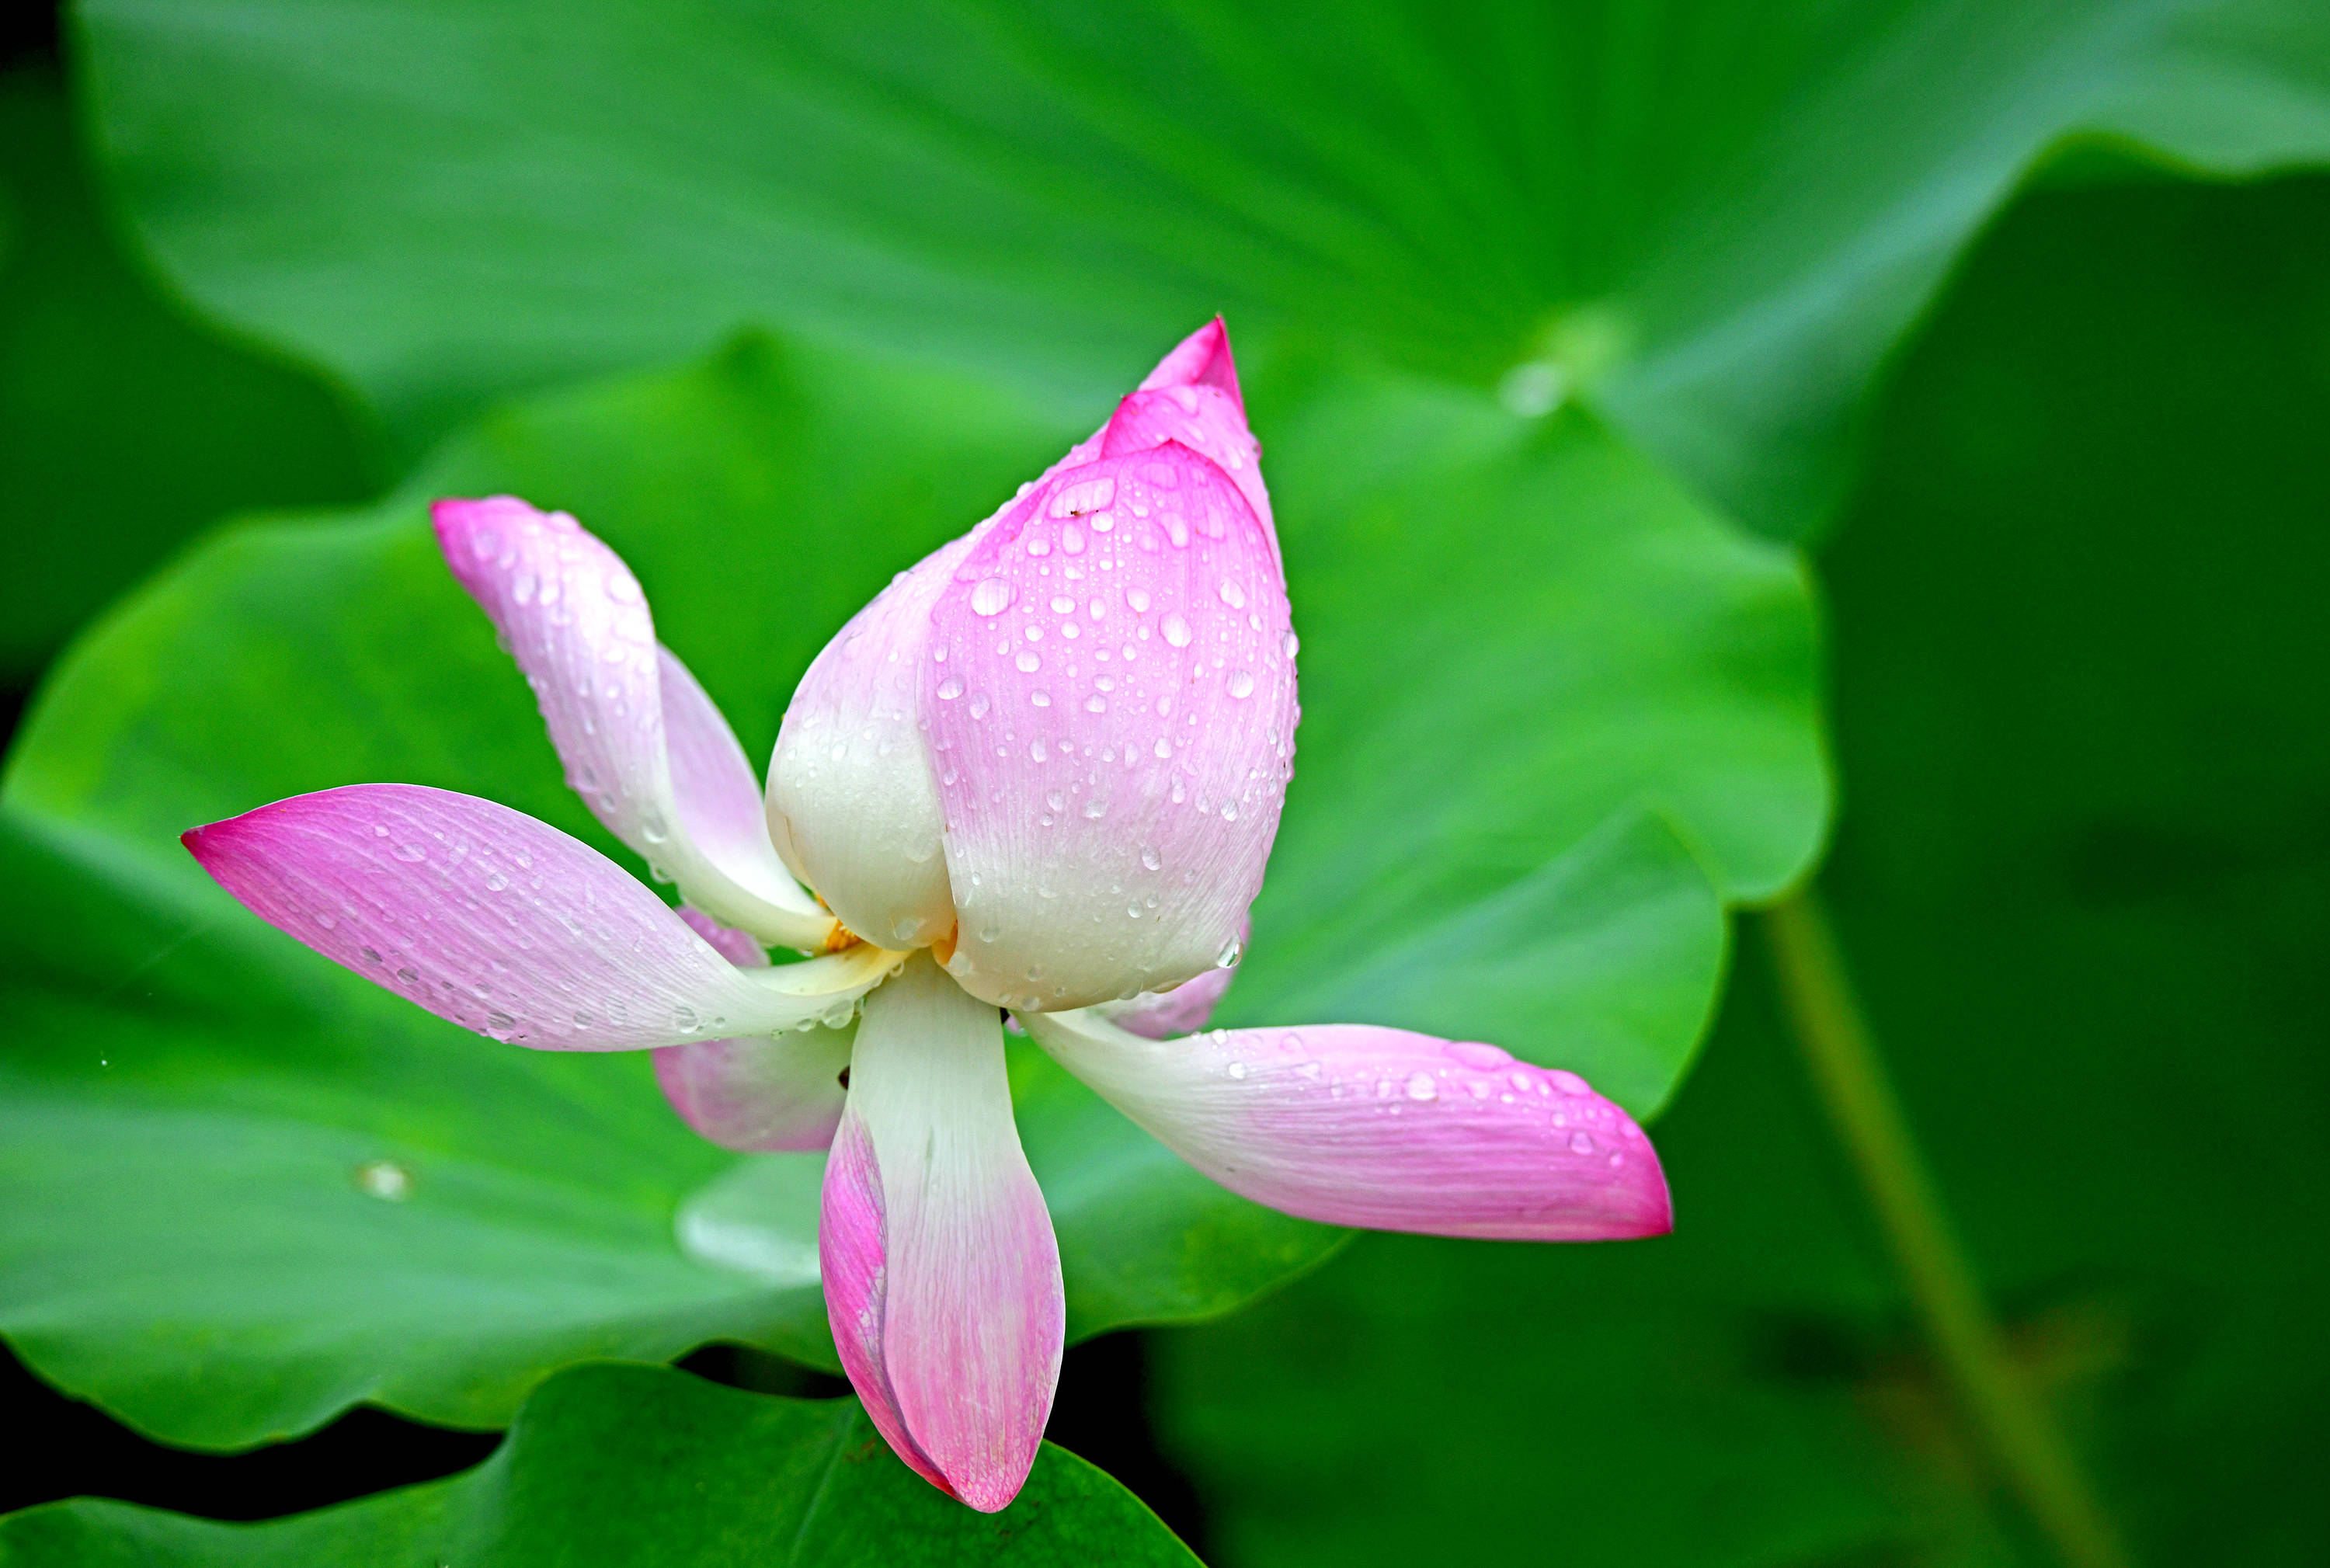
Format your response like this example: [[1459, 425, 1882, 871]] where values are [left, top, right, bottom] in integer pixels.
[[818, 953, 1067, 1512]]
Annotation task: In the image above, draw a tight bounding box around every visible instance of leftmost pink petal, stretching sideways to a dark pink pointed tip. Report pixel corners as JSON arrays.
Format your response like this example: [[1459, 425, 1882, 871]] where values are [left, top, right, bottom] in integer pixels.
[[184, 785, 897, 1051]]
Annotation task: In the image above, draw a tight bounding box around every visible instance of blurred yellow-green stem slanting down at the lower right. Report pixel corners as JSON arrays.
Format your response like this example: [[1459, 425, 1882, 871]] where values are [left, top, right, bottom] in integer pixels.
[[1764, 890, 2127, 1568]]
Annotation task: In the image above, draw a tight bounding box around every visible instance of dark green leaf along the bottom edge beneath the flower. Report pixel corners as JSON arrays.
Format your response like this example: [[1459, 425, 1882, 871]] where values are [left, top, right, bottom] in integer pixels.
[[0, 1365, 1198, 1568]]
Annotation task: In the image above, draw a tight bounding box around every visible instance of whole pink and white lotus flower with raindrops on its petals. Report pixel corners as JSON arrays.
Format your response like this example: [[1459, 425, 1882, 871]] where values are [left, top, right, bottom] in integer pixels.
[[186, 322, 1668, 1510]]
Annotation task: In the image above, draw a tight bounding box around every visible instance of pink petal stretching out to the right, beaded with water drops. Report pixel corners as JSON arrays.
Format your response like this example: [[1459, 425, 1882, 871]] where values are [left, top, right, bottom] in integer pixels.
[[1021, 1013, 1673, 1242]]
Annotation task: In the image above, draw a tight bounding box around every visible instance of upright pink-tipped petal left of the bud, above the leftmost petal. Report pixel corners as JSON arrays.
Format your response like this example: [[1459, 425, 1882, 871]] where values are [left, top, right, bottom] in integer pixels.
[[433, 496, 832, 951]]
